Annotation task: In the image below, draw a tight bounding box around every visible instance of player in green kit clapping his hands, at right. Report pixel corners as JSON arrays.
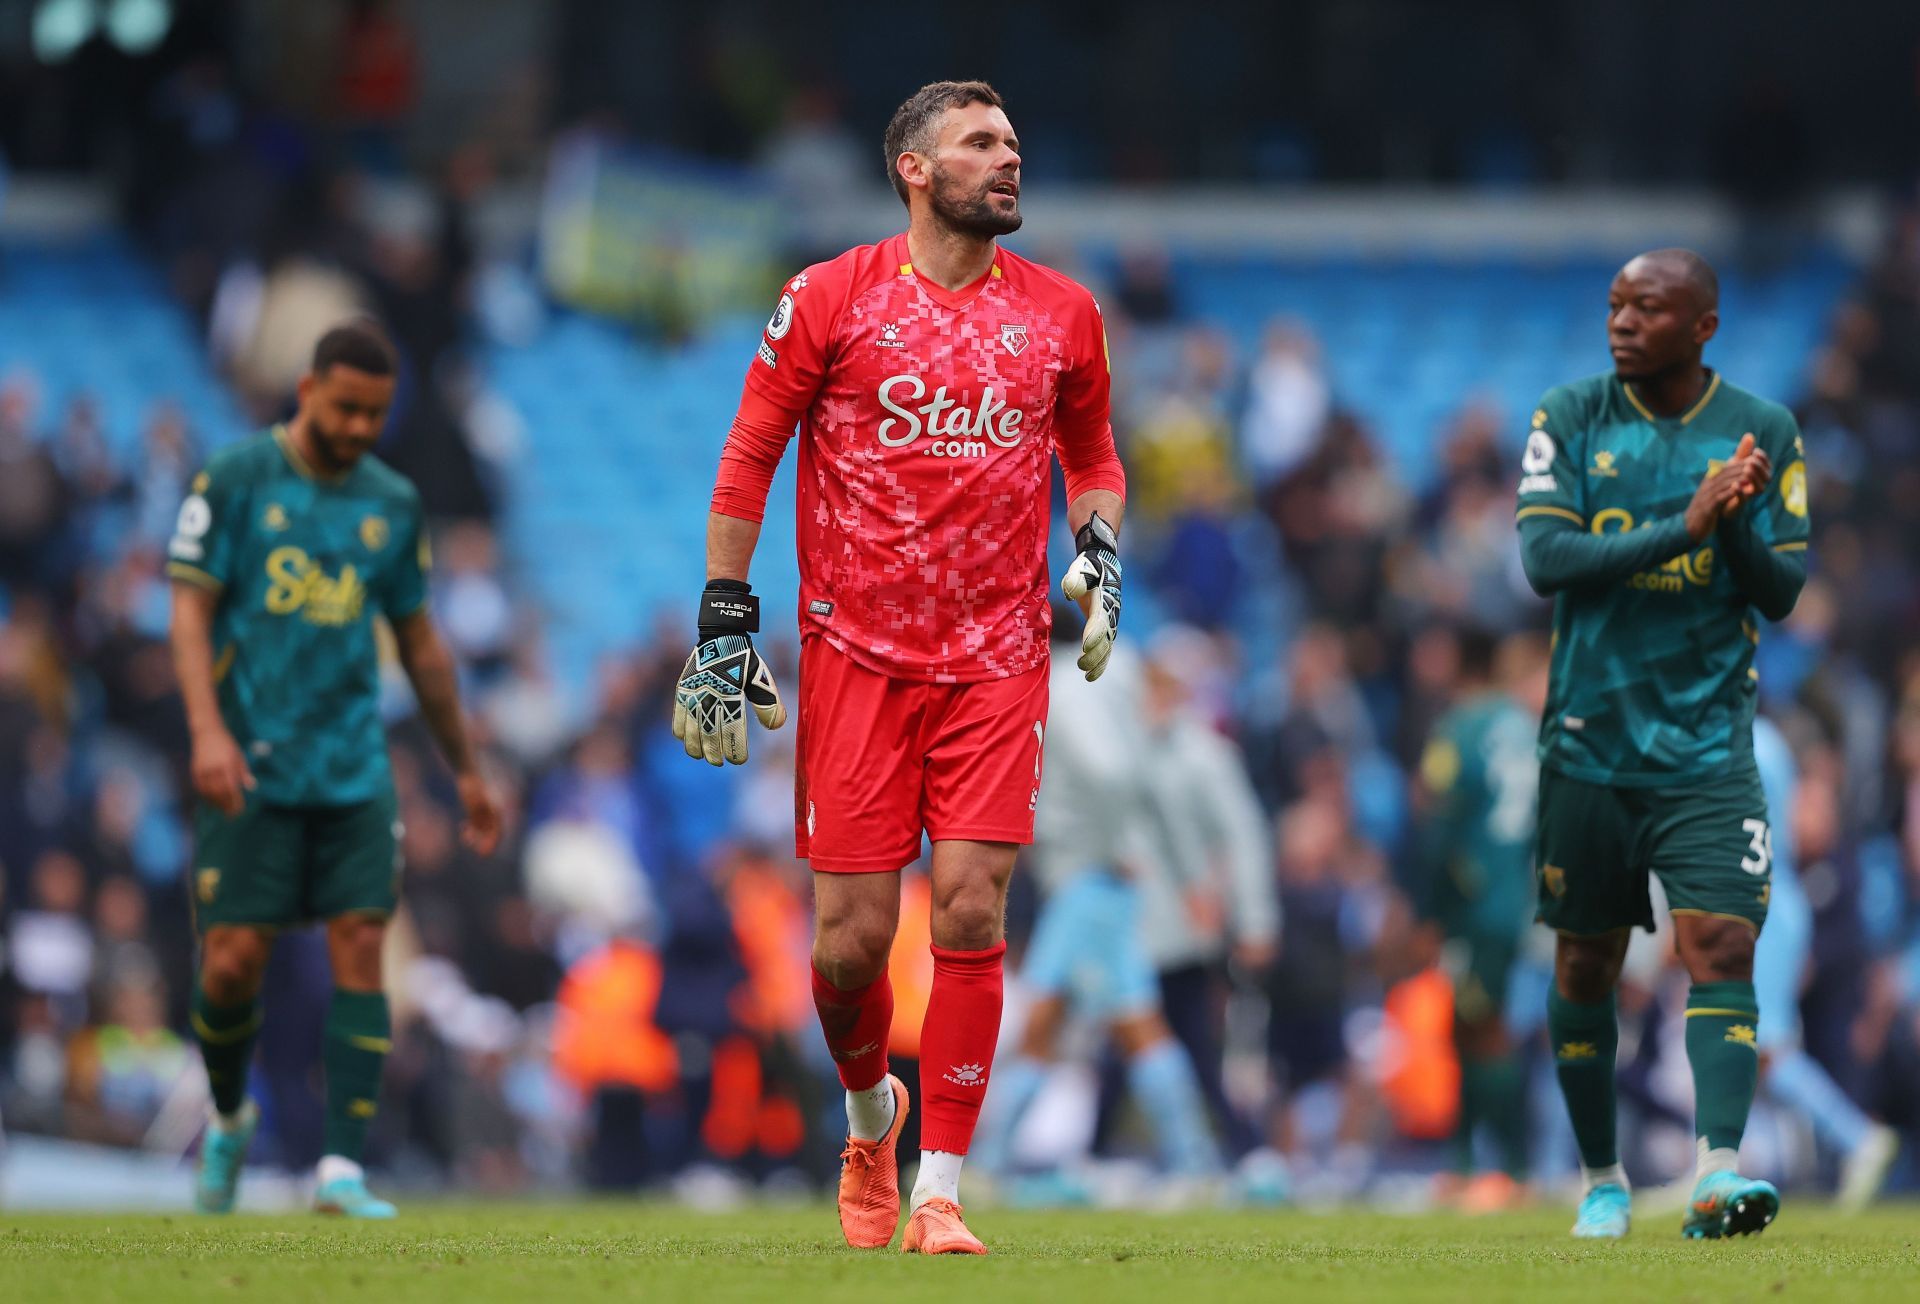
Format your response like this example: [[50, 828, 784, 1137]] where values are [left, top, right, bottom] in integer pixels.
[[1519, 250, 1807, 1237]]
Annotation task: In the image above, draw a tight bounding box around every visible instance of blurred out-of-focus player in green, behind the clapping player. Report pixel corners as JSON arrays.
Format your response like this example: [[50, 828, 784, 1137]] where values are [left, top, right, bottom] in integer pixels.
[[1409, 630, 1546, 1212]]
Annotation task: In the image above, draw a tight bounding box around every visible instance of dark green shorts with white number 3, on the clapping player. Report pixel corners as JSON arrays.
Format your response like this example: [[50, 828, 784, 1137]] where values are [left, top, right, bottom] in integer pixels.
[[1534, 768, 1774, 933]]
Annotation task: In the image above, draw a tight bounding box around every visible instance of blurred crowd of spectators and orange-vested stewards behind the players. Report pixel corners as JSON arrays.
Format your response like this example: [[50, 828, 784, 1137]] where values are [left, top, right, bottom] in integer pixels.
[[0, 12, 1920, 1195]]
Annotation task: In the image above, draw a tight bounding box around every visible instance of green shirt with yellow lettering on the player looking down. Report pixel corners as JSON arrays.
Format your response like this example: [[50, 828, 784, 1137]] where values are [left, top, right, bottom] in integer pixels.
[[167, 426, 428, 807]]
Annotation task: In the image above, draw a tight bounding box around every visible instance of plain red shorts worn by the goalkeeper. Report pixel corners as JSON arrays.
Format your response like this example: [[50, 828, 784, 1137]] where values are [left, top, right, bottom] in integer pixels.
[[793, 638, 1046, 874]]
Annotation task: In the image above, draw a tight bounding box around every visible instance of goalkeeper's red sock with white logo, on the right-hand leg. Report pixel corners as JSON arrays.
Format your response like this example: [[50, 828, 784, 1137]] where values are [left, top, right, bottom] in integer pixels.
[[920, 941, 1006, 1154]]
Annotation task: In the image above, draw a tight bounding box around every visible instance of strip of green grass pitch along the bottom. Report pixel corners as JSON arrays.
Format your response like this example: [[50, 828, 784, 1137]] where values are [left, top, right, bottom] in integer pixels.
[[0, 1202, 1920, 1304]]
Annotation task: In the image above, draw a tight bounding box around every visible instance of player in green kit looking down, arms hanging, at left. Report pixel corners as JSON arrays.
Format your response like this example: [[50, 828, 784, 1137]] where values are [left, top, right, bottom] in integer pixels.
[[167, 323, 499, 1218]]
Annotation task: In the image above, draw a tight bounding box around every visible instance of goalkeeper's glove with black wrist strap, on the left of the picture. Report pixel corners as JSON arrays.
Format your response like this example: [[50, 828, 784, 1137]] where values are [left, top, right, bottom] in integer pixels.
[[674, 580, 787, 764]]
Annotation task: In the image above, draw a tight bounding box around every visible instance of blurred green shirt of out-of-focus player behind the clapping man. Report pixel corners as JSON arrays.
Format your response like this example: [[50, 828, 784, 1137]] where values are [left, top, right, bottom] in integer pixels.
[[1417, 691, 1540, 935]]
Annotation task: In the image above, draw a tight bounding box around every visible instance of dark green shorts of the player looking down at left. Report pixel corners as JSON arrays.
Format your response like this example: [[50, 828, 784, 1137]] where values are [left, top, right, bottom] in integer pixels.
[[188, 793, 399, 931]]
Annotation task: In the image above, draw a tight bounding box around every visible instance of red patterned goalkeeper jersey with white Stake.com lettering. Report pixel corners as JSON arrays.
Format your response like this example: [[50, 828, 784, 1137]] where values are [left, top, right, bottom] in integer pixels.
[[712, 234, 1125, 682]]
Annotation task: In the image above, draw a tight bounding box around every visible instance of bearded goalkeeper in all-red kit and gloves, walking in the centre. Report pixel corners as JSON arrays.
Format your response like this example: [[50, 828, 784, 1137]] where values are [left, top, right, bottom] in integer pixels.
[[674, 83, 1125, 1254]]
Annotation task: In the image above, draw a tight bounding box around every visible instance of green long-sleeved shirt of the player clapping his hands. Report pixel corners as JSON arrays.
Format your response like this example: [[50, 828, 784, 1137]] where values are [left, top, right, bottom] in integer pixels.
[[1519, 373, 1809, 787]]
